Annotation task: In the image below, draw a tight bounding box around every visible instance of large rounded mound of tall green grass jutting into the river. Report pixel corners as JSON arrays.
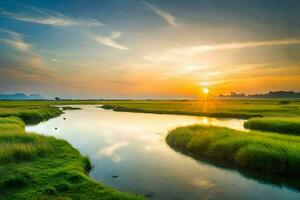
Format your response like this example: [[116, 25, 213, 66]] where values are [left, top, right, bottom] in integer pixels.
[[166, 125, 300, 177]]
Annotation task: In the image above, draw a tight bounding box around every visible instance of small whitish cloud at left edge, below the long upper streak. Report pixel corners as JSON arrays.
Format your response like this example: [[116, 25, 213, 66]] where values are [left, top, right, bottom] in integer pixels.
[[0, 29, 31, 52]]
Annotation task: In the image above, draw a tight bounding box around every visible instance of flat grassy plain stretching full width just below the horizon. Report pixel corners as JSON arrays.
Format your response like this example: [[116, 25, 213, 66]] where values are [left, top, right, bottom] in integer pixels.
[[0, 99, 300, 118]]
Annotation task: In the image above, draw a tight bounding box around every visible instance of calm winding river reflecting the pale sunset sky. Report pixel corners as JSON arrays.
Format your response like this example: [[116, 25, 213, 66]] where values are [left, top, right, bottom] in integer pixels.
[[26, 106, 300, 200]]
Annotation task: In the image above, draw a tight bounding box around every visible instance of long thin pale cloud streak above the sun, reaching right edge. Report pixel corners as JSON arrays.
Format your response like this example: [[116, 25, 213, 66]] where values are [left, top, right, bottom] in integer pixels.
[[172, 38, 300, 55]]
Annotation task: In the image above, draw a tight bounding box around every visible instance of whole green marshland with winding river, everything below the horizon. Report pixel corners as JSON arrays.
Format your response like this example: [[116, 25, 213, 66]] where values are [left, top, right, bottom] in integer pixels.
[[0, 99, 300, 199]]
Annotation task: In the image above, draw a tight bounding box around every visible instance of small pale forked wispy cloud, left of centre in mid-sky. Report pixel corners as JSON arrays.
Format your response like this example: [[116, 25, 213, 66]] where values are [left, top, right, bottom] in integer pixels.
[[94, 32, 129, 50]]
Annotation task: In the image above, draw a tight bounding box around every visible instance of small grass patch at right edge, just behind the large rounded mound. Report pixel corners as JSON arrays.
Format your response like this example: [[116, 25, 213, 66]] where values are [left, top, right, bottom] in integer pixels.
[[244, 118, 300, 135]]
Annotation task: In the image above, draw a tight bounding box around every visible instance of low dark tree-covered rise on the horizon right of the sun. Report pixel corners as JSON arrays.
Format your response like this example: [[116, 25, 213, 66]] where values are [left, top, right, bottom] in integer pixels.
[[219, 91, 300, 98]]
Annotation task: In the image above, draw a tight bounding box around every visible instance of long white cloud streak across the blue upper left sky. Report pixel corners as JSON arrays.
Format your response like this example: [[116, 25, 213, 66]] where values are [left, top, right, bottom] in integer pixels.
[[0, 5, 105, 26]]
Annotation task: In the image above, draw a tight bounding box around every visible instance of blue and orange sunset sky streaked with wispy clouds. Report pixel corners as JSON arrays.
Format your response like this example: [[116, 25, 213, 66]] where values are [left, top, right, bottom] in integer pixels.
[[0, 0, 300, 98]]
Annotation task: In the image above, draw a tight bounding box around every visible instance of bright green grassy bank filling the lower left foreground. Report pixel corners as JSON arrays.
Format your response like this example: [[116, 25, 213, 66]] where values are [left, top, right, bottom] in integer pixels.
[[0, 117, 143, 200]]
